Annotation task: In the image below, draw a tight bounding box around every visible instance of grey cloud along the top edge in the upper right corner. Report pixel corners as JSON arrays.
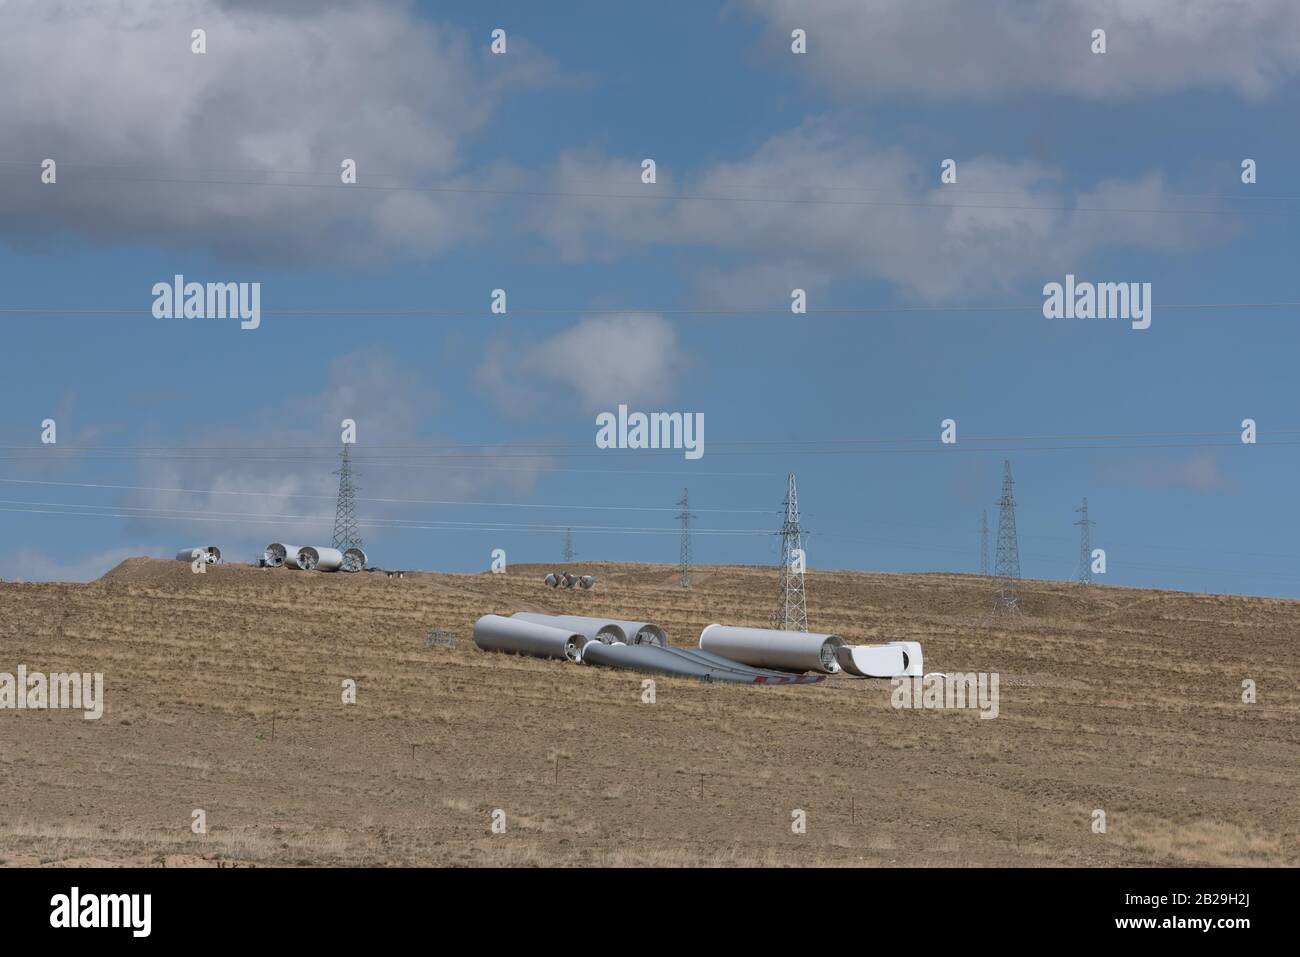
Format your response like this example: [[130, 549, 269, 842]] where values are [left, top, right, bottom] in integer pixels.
[[748, 0, 1300, 100]]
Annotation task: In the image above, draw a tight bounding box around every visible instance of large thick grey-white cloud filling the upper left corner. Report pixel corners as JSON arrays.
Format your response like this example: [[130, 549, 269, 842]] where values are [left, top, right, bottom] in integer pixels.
[[0, 0, 550, 263]]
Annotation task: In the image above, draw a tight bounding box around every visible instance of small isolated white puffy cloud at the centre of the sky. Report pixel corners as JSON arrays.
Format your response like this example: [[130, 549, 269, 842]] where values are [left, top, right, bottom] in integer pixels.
[[477, 313, 686, 416]]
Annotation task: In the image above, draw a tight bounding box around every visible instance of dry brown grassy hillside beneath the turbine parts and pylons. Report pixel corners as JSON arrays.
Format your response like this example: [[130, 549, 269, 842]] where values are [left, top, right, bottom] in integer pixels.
[[0, 559, 1300, 866]]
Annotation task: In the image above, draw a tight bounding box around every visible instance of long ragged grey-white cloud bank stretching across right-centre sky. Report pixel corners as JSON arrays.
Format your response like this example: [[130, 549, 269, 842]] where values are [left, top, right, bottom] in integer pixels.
[[528, 118, 1231, 300]]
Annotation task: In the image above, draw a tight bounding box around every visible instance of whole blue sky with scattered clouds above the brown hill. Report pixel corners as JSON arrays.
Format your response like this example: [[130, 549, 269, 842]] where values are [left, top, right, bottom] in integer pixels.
[[0, 0, 1300, 601]]
